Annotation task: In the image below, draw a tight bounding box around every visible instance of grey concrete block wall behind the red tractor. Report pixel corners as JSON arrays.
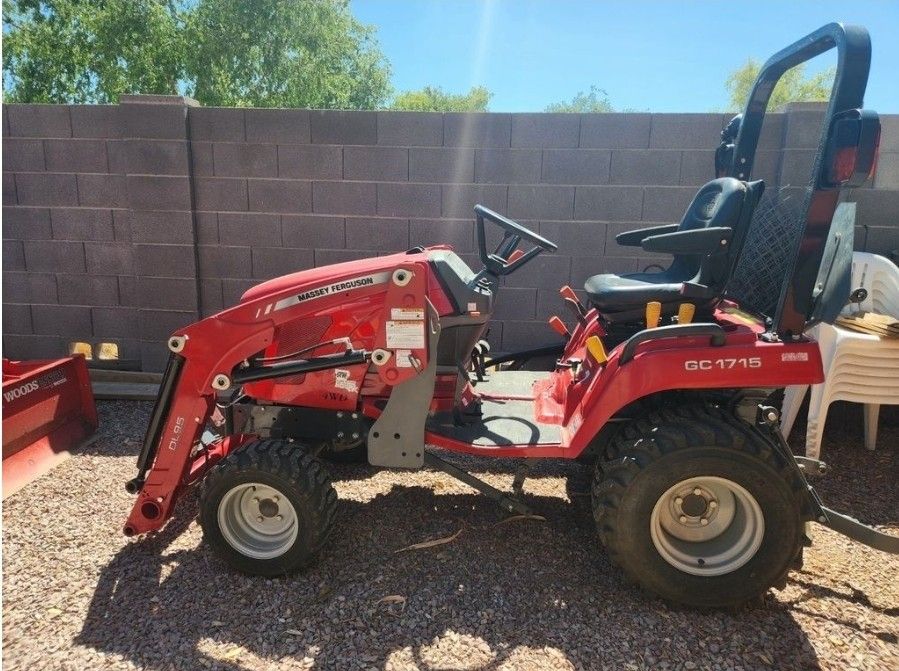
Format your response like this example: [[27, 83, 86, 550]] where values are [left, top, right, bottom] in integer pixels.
[[3, 96, 899, 370]]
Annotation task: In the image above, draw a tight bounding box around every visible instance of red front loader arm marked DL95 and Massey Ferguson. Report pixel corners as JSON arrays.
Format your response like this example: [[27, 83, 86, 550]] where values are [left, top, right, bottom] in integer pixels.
[[124, 253, 433, 536]]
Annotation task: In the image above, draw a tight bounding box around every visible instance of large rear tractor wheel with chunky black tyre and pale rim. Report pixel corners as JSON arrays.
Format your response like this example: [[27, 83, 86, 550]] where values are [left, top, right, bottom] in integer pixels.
[[592, 406, 803, 607]]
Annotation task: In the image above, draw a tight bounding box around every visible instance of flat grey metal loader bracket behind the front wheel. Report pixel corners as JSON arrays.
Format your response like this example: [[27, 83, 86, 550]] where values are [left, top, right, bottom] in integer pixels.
[[368, 299, 440, 468]]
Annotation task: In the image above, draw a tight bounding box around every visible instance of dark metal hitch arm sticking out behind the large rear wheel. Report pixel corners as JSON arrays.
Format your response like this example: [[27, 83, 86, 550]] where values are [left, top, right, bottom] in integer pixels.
[[756, 405, 899, 554]]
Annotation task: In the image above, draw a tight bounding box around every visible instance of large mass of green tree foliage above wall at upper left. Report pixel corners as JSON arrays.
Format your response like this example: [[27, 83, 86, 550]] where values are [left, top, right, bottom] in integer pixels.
[[3, 0, 390, 109]]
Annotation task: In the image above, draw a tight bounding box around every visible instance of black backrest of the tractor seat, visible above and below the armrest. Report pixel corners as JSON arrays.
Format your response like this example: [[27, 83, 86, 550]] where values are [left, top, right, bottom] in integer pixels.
[[665, 177, 746, 281]]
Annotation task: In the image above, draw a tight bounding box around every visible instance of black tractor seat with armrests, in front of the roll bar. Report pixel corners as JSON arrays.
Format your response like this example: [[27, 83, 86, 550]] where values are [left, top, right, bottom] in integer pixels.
[[584, 177, 764, 321]]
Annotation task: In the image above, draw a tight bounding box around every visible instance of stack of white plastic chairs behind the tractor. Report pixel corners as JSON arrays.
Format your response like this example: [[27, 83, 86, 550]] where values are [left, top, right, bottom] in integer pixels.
[[781, 252, 899, 459]]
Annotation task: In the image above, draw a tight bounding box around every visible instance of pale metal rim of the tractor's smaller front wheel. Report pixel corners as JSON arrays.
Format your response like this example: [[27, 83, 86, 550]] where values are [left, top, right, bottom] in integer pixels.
[[218, 482, 299, 559]]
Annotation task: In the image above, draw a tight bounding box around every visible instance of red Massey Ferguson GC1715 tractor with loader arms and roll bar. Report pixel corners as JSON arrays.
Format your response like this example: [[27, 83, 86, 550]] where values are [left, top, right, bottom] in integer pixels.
[[124, 24, 899, 606]]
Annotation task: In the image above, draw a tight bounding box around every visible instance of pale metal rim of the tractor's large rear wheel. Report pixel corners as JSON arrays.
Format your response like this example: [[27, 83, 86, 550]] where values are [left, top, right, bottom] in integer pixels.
[[650, 476, 765, 576]]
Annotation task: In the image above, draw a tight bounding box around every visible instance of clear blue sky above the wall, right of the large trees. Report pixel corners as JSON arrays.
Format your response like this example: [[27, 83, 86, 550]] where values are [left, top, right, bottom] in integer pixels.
[[351, 0, 899, 114]]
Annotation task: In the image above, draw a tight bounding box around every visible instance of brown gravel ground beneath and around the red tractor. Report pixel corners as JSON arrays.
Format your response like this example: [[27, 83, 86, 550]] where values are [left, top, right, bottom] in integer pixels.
[[3, 402, 899, 671]]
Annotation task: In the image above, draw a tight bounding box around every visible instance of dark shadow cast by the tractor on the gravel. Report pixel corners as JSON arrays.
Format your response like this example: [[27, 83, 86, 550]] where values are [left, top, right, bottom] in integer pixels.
[[77, 476, 818, 671]]
